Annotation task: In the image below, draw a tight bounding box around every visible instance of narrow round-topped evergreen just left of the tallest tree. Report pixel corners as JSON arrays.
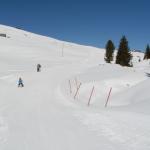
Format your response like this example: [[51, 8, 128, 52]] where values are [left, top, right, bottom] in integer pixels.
[[105, 40, 115, 63]]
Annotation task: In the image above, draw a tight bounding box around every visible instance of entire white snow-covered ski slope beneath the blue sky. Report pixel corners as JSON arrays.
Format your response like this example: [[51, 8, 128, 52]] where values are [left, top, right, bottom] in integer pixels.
[[0, 25, 150, 150]]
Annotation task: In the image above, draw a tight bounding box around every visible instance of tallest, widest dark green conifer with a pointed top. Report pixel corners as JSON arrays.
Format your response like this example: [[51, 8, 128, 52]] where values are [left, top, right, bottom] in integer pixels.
[[116, 36, 132, 67]]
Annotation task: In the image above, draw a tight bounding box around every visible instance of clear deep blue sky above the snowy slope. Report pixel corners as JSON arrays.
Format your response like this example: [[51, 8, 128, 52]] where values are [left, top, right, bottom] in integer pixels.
[[0, 0, 150, 50]]
